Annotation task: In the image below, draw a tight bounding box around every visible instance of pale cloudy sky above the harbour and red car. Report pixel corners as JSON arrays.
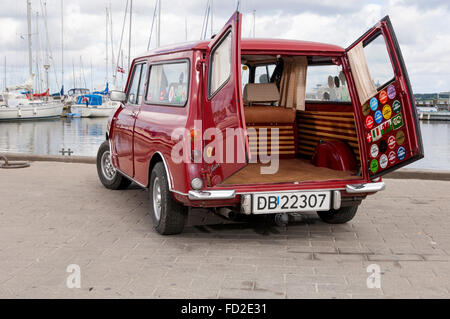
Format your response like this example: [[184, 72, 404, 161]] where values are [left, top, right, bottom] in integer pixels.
[[0, 0, 450, 93]]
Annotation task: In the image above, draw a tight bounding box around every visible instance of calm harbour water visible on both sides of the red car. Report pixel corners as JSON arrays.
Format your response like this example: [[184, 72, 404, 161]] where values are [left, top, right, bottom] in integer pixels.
[[0, 118, 450, 170]]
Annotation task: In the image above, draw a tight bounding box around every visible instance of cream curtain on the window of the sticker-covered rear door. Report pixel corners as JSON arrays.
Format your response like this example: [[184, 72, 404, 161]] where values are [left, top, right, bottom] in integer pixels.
[[347, 42, 377, 105]]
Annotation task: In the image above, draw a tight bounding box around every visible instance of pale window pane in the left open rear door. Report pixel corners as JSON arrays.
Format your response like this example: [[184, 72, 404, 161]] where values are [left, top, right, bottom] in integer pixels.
[[209, 32, 231, 96]]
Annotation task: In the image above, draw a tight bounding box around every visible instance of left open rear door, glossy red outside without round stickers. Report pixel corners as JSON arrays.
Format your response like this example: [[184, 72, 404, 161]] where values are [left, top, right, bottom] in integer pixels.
[[202, 11, 248, 186]]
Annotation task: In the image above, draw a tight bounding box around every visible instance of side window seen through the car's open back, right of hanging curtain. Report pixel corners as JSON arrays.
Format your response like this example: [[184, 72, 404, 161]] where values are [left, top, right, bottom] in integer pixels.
[[306, 65, 350, 102]]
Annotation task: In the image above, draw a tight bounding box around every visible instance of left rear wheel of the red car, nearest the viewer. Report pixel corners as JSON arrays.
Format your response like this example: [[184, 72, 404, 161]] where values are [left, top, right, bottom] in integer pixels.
[[149, 162, 188, 235]]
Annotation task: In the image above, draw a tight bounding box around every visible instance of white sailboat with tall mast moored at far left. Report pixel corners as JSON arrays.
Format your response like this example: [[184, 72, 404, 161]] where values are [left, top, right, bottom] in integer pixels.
[[0, 0, 63, 120]]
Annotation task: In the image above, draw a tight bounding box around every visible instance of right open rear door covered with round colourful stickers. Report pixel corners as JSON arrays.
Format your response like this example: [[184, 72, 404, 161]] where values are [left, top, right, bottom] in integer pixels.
[[346, 16, 424, 179]]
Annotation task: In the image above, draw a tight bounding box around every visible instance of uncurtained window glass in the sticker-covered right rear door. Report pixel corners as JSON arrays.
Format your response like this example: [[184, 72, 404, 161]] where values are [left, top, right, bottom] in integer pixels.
[[364, 34, 394, 89]]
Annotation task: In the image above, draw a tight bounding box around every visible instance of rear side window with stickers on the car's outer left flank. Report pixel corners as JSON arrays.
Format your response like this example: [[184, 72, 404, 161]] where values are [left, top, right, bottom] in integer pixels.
[[146, 61, 189, 106]]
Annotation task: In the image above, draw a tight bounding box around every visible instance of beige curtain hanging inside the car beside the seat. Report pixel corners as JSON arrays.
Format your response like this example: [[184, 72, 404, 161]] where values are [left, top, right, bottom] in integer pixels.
[[280, 56, 308, 111]]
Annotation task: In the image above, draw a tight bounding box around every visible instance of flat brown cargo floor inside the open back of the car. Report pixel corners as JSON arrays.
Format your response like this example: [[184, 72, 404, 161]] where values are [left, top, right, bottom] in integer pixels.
[[222, 158, 360, 184]]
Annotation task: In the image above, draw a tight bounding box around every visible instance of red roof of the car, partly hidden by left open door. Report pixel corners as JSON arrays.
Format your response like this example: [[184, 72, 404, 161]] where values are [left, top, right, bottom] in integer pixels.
[[139, 39, 345, 57]]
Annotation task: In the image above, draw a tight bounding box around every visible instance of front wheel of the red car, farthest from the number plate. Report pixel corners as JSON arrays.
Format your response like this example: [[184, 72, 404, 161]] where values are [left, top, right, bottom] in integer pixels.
[[97, 141, 131, 189]]
